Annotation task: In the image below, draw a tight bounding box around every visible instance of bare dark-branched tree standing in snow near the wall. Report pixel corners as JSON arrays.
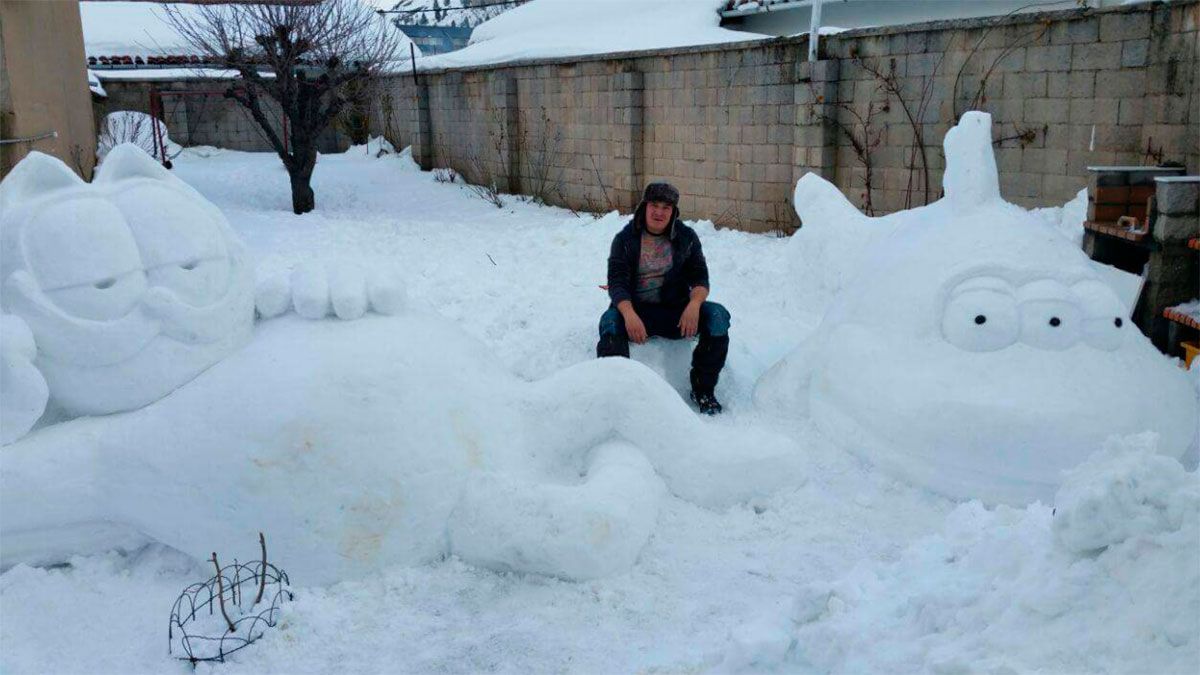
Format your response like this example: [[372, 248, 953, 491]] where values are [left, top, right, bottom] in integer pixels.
[[163, 0, 398, 214]]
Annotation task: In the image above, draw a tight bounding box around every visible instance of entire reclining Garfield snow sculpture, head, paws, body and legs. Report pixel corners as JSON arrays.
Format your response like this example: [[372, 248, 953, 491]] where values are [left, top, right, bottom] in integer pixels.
[[0, 148, 799, 584]]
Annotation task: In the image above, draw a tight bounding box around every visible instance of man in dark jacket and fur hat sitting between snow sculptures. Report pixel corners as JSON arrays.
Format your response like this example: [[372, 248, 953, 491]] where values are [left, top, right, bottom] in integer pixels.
[[596, 183, 730, 414]]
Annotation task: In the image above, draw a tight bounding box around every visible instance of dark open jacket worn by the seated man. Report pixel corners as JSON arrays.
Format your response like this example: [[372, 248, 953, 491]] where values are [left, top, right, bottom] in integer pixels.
[[608, 202, 709, 306]]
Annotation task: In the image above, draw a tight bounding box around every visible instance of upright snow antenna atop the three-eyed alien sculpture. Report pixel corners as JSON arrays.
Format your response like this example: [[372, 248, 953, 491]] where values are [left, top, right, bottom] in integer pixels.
[[942, 110, 1001, 210]]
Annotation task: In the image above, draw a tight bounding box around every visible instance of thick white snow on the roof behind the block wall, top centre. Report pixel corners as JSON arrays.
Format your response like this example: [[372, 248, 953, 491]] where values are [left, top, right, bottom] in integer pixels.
[[418, 0, 766, 68]]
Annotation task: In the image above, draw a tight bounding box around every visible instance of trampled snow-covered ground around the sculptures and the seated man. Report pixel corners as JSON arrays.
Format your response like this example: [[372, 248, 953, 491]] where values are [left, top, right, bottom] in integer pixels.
[[0, 144, 1200, 673]]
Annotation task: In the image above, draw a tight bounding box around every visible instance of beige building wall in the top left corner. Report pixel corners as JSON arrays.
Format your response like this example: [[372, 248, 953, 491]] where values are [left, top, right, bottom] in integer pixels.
[[0, 0, 96, 178]]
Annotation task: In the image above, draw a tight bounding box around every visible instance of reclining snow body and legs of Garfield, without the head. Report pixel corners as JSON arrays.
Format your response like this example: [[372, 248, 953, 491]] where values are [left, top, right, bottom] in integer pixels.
[[0, 312, 800, 585]]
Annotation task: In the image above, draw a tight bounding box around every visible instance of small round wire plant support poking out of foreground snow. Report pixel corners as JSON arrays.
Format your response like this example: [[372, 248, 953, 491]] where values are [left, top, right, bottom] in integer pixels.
[[167, 532, 295, 665]]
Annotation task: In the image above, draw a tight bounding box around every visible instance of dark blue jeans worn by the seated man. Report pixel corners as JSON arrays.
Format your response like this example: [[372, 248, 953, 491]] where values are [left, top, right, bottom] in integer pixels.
[[596, 301, 730, 394]]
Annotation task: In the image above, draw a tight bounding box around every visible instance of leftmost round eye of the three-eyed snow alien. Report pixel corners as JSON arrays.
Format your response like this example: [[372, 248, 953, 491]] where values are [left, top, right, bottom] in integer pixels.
[[942, 277, 1021, 352]]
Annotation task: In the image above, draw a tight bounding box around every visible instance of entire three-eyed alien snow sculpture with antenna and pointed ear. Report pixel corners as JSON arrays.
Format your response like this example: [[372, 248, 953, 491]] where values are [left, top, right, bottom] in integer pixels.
[[755, 113, 1198, 503]]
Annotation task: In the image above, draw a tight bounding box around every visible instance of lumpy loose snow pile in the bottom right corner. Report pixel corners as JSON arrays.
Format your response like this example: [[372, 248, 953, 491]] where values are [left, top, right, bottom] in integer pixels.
[[726, 437, 1200, 673]]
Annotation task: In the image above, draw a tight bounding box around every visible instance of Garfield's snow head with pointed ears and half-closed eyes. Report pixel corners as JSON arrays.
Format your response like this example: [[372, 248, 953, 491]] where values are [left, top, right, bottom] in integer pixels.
[[0, 145, 253, 414]]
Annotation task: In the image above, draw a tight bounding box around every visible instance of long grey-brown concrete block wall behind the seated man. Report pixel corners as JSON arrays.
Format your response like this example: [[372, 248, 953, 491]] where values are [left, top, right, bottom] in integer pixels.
[[374, 1, 1200, 231]]
